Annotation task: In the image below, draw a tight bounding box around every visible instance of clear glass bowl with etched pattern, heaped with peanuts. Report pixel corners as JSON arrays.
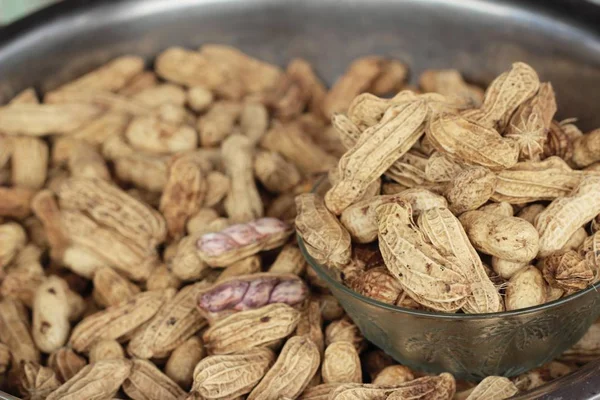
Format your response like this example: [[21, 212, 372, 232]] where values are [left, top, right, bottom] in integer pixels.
[[298, 179, 600, 380]]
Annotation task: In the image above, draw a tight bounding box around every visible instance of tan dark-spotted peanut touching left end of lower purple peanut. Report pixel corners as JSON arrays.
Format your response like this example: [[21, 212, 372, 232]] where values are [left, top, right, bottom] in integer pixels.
[[127, 281, 207, 359]]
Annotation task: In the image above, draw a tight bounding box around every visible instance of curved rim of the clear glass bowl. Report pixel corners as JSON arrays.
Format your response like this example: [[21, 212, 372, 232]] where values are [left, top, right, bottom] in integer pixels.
[[296, 174, 600, 320]]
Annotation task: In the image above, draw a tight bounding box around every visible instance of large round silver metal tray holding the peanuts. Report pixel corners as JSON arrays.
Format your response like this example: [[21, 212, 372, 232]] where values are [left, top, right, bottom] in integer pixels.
[[0, 0, 600, 400]]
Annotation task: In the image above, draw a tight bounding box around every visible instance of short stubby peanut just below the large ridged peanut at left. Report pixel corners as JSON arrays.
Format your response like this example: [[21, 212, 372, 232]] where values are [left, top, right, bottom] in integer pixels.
[[93, 267, 140, 307]]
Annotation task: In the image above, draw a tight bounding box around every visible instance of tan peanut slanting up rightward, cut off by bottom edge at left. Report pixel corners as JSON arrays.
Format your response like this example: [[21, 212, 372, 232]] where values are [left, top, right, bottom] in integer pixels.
[[47, 360, 132, 400]]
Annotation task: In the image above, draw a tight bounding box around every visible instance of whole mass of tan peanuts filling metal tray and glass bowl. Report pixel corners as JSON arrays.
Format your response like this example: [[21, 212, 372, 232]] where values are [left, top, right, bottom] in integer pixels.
[[0, 44, 600, 400]]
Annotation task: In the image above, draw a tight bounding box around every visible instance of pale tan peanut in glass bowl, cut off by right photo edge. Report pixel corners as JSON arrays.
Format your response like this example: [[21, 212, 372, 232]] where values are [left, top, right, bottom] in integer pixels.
[[535, 175, 600, 257]]
